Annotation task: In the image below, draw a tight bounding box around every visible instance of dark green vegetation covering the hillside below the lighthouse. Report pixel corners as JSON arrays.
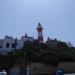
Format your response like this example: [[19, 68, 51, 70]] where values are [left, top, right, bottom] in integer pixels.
[[0, 39, 75, 68]]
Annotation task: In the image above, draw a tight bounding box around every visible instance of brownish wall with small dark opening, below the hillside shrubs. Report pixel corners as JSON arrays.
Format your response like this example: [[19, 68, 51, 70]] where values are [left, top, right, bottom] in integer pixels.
[[30, 63, 55, 75]]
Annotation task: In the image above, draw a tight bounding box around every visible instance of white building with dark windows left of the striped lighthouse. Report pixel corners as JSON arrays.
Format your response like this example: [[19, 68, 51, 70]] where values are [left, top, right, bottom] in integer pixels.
[[0, 36, 34, 54]]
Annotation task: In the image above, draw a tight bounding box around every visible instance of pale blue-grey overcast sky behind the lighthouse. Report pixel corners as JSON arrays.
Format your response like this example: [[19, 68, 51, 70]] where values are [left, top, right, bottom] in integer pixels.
[[0, 0, 75, 45]]
